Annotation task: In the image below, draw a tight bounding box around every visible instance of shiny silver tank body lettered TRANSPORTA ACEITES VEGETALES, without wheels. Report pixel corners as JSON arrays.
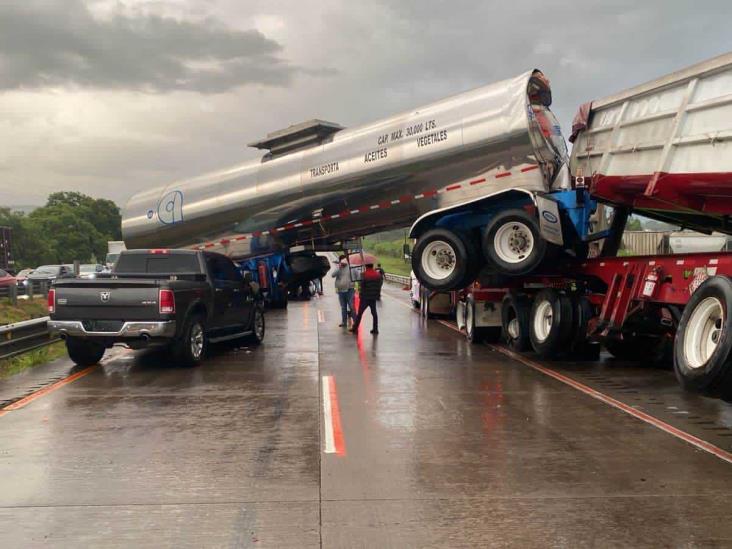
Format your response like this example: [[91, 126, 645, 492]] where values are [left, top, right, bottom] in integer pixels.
[[122, 70, 566, 257]]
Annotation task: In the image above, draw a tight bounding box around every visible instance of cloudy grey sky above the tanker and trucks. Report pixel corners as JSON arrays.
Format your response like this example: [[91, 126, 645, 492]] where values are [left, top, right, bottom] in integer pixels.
[[0, 0, 732, 205]]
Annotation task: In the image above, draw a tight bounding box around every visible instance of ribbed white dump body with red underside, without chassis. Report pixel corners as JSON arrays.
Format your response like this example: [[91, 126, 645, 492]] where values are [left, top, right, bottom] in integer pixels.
[[571, 54, 732, 227]]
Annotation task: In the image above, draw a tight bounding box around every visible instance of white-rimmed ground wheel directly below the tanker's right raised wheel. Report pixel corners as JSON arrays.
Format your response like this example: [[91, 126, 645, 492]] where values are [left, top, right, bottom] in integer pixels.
[[529, 288, 574, 358]]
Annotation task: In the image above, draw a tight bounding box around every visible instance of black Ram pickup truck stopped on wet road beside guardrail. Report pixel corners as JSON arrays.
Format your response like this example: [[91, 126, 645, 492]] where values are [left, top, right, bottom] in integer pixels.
[[48, 250, 264, 366]]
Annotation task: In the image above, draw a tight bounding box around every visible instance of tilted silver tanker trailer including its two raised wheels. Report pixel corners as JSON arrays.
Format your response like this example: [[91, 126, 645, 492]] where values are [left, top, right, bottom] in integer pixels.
[[122, 70, 570, 290]]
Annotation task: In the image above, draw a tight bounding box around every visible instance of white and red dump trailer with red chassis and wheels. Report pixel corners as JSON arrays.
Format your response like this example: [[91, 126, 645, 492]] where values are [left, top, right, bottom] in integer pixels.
[[457, 54, 732, 397]]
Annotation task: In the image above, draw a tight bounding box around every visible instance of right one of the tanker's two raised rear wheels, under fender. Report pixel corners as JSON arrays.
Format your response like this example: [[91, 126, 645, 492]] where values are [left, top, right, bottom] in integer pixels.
[[483, 210, 547, 276]]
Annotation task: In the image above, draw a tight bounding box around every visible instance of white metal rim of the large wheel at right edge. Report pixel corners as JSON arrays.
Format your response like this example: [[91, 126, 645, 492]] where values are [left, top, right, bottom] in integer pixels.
[[684, 297, 724, 369]]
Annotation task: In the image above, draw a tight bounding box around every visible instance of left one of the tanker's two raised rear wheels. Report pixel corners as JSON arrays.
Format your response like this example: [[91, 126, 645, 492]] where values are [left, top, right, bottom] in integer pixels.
[[412, 228, 480, 292]]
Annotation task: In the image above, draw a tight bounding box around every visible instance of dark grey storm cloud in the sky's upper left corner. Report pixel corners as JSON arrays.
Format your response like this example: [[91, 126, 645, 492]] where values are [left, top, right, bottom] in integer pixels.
[[0, 0, 299, 93]]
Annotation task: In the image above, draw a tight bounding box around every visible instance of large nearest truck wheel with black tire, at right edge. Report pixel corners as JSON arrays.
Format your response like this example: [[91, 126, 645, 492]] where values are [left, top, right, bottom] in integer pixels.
[[674, 276, 732, 397]]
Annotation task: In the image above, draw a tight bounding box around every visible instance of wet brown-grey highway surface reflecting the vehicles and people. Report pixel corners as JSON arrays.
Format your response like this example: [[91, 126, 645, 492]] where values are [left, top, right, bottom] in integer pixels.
[[0, 280, 732, 547]]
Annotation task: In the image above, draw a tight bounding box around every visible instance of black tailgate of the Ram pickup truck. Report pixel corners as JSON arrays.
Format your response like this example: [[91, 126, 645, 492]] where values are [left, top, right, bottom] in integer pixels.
[[54, 279, 160, 320]]
